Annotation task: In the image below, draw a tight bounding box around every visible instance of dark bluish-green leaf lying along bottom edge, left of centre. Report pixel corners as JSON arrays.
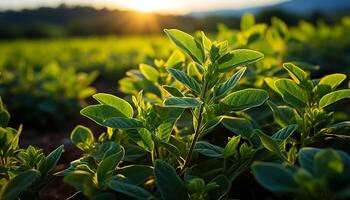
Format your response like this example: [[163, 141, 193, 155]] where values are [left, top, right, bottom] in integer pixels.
[[108, 179, 153, 200]]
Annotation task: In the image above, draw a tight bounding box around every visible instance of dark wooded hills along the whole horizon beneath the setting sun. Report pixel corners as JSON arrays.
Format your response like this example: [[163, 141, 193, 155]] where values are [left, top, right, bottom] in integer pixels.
[[0, 3, 350, 39]]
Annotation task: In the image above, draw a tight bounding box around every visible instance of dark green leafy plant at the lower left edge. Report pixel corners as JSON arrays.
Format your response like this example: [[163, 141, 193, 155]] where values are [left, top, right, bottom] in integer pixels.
[[0, 98, 63, 200]]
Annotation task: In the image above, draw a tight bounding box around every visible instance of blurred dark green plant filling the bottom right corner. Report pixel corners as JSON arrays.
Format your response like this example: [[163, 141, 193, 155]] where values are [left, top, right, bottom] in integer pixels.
[[252, 147, 350, 199]]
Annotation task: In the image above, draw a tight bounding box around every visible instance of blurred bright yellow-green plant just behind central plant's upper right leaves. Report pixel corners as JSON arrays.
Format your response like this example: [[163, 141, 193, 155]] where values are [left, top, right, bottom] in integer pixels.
[[217, 13, 290, 87]]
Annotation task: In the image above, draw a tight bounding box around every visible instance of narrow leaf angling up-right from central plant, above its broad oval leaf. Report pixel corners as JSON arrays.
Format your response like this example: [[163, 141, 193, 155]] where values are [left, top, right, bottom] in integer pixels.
[[214, 67, 247, 98]]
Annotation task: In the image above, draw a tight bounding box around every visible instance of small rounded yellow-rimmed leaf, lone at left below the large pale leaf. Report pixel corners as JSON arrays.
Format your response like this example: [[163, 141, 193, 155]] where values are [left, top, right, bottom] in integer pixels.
[[70, 125, 95, 152]]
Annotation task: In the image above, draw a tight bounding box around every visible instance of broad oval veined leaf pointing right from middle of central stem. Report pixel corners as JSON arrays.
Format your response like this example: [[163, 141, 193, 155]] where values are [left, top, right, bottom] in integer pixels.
[[220, 88, 269, 110]]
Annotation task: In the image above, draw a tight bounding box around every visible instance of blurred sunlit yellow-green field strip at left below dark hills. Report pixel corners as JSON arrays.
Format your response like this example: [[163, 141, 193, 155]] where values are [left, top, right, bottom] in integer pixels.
[[0, 36, 171, 74]]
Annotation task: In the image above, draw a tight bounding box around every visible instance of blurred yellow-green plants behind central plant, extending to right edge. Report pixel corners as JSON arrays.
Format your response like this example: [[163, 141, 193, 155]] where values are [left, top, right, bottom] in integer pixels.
[[216, 13, 350, 87]]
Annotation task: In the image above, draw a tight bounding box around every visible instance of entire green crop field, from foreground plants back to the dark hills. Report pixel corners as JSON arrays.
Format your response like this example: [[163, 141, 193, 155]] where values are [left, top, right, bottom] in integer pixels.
[[0, 10, 350, 200]]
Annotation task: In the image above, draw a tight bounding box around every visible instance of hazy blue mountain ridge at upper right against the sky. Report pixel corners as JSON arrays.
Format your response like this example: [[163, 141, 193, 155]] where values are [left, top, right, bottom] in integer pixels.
[[188, 0, 350, 17]]
